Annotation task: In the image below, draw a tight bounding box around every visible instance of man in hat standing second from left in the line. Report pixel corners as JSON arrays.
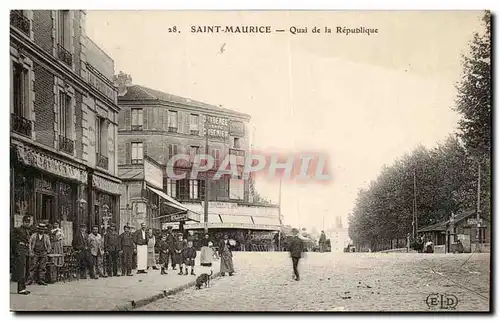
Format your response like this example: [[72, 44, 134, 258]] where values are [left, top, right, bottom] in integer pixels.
[[28, 223, 51, 285]]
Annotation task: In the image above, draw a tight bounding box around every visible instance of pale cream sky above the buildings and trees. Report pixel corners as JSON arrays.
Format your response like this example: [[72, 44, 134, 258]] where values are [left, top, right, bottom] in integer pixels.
[[86, 11, 482, 230]]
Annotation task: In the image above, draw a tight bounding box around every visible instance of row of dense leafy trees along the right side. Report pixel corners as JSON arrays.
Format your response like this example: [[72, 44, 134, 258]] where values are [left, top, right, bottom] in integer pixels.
[[349, 12, 492, 250]]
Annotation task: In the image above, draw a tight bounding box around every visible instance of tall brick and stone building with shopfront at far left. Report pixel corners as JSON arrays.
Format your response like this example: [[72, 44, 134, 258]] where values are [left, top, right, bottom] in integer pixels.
[[10, 10, 121, 246]]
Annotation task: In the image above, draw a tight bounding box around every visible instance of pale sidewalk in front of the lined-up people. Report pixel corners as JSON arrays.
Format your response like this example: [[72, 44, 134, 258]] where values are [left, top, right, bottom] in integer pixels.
[[10, 252, 220, 311]]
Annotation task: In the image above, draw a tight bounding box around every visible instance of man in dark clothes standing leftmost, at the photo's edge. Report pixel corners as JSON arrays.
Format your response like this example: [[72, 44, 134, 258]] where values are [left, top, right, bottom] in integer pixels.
[[14, 215, 30, 295]]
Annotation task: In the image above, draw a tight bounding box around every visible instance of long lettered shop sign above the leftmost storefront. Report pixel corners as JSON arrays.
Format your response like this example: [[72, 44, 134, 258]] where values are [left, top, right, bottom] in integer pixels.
[[17, 146, 87, 184]]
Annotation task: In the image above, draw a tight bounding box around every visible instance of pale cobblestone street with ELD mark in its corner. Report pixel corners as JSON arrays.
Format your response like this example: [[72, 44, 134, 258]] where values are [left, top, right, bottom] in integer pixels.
[[137, 252, 490, 311]]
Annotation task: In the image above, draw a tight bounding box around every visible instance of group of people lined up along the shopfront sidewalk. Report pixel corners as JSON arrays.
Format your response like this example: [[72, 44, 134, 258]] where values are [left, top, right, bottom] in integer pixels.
[[13, 216, 238, 295]]
